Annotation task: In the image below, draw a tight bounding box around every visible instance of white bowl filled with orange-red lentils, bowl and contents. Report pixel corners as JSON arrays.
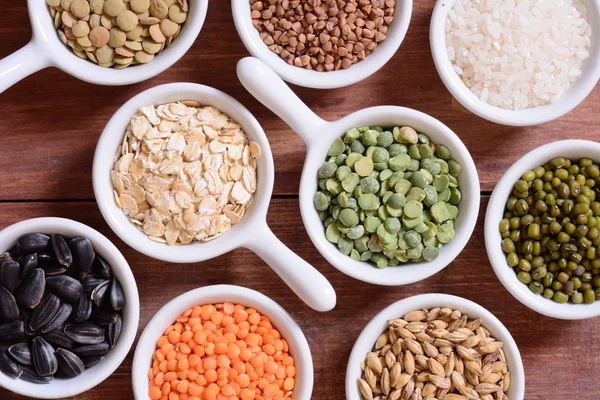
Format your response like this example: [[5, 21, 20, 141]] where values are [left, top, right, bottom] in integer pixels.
[[132, 285, 313, 400]]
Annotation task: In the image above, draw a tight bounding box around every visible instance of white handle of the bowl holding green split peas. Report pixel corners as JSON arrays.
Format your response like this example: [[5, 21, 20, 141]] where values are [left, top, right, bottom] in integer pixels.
[[237, 57, 328, 147]]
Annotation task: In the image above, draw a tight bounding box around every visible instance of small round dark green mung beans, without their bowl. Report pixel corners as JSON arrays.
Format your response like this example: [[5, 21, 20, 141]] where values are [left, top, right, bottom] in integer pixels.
[[502, 156, 600, 304]]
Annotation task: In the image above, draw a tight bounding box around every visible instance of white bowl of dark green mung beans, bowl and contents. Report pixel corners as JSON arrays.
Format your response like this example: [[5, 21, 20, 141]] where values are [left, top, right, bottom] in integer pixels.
[[485, 140, 600, 319]]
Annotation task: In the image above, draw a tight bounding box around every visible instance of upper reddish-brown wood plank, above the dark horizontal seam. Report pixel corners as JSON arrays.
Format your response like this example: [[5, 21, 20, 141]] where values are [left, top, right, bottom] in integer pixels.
[[0, 0, 600, 200]]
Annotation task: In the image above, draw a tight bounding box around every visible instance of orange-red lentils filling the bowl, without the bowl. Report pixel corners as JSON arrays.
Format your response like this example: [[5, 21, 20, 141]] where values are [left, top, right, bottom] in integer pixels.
[[148, 303, 296, 400]]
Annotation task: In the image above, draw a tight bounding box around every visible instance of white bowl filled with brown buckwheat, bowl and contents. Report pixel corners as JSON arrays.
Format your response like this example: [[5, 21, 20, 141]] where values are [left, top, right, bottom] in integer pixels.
[[232, 0, 412, 89]]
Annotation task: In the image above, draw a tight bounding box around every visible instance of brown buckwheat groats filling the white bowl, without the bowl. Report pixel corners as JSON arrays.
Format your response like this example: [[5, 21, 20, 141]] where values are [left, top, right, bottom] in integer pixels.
[[250, 0, 396, 71]]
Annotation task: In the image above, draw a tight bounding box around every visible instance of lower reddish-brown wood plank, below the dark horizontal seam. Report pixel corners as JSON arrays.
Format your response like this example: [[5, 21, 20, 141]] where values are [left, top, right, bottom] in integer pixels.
[[0, 197, 600, 400]]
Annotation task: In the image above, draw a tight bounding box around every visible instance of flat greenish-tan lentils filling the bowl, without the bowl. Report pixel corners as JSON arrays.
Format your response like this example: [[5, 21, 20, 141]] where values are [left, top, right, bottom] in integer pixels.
[[46, 0, 188, 69]]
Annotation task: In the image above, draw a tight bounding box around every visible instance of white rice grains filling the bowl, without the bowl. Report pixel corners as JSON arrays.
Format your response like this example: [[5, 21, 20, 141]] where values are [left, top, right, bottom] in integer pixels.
[[445, 0, 591, 110]]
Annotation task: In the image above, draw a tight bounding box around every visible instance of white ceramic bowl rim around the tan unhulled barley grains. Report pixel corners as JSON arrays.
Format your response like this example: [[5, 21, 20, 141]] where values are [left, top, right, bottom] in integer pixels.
[[346, 293, 525, 400]]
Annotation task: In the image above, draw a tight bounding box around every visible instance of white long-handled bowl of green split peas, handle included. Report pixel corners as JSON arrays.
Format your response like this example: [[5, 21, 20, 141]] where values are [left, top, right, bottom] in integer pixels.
[[238, 58, 479, 285]]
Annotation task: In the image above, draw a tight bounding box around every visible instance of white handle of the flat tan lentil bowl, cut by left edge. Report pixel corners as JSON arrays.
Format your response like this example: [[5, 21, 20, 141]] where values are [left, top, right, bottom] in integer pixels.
[[0, 40, 50, 93]]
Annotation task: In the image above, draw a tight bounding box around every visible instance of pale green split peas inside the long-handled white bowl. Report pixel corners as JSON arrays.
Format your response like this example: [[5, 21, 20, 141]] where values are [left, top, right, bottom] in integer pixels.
[[313, 126, 462, 270]]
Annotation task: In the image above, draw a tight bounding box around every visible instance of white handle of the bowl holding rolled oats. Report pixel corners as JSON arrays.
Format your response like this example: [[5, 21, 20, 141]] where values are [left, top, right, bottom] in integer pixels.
[[245, 223, 336, 311]]
